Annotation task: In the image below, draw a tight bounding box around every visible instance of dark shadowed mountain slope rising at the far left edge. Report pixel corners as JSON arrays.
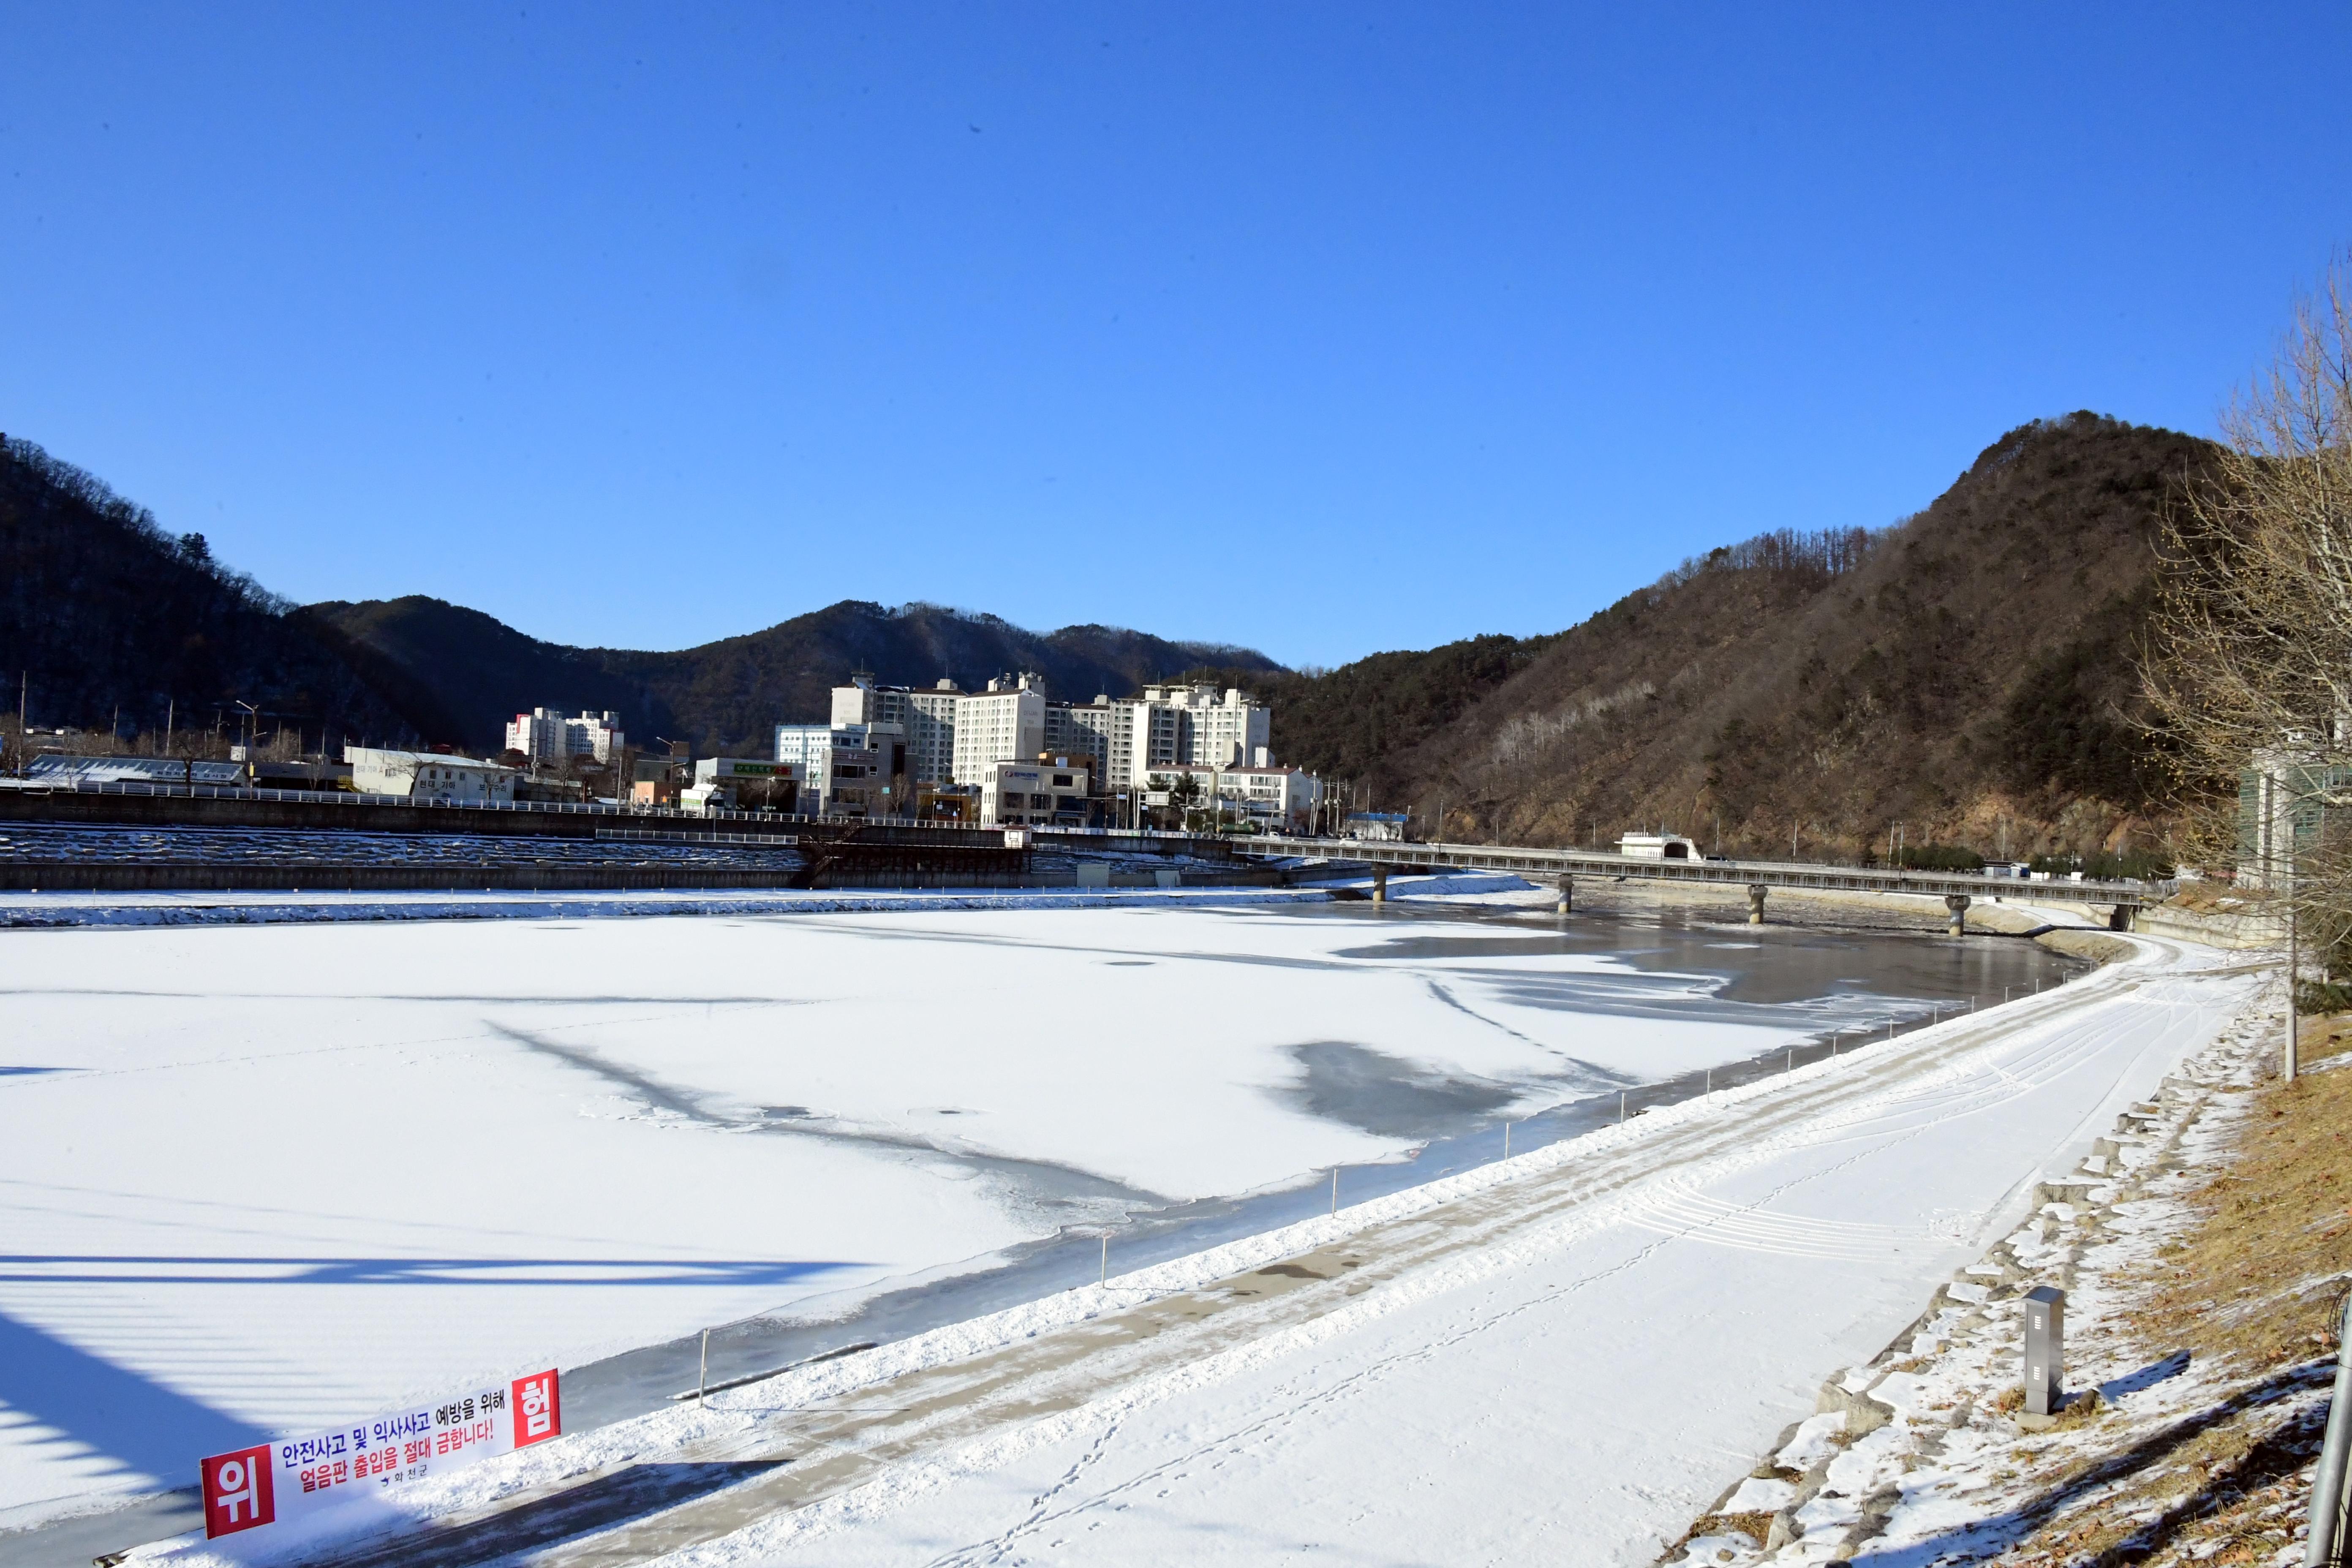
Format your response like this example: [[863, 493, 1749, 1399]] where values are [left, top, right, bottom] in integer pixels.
[[0, 437, 414, 740]]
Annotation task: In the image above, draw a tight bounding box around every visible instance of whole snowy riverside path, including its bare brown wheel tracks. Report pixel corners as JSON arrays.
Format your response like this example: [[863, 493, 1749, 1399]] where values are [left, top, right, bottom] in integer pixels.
[[147, 940, 2251, 1565]]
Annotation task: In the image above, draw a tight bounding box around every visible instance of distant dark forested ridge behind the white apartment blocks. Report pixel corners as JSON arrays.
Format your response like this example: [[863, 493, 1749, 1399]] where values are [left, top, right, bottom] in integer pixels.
[[303, 597, 1282, 754]]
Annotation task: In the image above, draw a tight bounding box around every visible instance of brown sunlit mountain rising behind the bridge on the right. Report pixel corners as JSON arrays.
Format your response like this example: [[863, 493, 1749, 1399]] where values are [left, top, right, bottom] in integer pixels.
[[1204, 414, 2213, 856]]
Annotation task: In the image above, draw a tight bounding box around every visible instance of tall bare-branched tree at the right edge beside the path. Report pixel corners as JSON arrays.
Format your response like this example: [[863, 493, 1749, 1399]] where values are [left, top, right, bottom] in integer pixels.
[[2148, 254, 2352, 969]]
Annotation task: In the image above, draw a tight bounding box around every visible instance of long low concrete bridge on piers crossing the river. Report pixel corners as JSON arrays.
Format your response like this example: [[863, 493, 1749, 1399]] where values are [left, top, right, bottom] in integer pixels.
[[1233, 837, 2178, 928]]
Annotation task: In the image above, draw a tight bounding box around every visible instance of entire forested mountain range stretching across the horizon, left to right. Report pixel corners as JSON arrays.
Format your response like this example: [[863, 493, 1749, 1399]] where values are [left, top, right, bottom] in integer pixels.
[[0, 414, 2213, 856]]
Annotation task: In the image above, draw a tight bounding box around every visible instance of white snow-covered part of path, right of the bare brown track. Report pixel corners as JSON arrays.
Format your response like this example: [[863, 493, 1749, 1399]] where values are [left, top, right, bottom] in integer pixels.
[[644, 945, 2249, 1565]]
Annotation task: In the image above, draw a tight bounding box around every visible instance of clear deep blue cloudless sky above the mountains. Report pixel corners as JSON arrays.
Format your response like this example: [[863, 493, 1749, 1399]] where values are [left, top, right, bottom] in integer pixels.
[[0, 0, 2352, 663]]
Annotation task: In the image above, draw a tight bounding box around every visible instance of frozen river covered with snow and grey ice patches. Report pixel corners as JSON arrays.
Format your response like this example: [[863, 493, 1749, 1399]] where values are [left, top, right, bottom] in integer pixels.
[[0, 888, 2063, 1528]]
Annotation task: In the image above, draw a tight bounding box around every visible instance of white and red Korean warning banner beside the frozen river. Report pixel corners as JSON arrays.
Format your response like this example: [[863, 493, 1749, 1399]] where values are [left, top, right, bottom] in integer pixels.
[[198, 1368, 564, 1540]]
